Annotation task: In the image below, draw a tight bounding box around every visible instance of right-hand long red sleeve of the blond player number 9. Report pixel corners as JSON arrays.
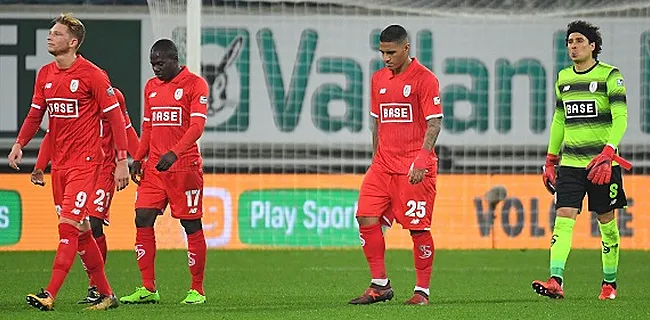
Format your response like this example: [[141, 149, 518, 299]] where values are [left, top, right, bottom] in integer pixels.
[[90, 72, 128, 160]]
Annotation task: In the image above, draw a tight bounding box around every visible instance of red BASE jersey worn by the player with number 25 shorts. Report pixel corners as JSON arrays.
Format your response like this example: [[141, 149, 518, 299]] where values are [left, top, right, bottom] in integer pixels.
[[370, 58, 442, 174]]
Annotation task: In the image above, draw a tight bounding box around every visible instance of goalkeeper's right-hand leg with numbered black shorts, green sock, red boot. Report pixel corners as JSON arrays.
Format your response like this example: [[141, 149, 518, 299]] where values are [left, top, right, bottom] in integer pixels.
[[587, 166, 627, 300]]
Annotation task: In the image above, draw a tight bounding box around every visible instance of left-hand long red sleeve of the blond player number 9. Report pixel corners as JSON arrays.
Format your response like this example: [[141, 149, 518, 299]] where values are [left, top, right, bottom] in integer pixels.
[[16, 66, 48, 148]]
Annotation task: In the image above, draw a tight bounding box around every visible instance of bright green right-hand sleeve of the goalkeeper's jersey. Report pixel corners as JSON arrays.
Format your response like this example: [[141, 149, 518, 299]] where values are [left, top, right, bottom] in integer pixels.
[[607, 69, 627, 148]]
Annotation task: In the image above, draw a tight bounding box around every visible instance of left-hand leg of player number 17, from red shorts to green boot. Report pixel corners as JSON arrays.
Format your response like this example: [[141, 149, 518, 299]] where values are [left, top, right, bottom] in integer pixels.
[[120, 169, 167, 304]]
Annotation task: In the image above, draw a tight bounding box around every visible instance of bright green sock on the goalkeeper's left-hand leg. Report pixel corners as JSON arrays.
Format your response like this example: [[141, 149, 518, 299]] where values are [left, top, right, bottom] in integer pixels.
[[551, 217, 572, 279]]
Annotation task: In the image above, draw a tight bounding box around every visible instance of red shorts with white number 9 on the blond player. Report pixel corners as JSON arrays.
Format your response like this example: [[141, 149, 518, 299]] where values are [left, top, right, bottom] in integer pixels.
[[52, 164, 100, 222]]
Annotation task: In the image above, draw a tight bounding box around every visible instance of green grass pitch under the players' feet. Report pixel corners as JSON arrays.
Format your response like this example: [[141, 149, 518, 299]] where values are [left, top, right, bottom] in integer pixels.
[[0, 250, 650, 320]]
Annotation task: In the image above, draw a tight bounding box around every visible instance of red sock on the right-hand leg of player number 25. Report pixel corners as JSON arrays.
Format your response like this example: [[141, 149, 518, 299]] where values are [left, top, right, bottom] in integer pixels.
[[411, 231, 435, 294]]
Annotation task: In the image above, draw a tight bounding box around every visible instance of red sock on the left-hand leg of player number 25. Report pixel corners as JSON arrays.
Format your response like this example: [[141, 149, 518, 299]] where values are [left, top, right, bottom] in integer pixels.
[[359, 223, 387, 279]]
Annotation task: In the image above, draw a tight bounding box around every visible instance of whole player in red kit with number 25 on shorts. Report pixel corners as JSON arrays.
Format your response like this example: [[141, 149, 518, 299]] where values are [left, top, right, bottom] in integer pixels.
[[350, 25, 442, 304]]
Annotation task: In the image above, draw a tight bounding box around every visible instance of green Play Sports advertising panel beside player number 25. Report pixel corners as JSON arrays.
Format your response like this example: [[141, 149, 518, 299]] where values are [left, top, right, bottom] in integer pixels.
[[238, 189, 359, 247]]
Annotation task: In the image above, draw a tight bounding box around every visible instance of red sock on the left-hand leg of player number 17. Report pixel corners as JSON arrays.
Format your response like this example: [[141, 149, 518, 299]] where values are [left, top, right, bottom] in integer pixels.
[[135, 228, 156, 292]]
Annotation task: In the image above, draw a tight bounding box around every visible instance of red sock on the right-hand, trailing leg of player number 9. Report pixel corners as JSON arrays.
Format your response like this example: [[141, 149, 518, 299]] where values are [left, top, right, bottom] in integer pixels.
[[79, 231, 113, 295]]
